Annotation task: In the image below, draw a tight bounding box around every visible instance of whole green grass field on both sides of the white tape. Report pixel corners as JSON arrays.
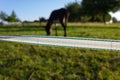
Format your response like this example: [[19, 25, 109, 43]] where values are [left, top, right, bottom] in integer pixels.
[[0, 23, 120, 80]]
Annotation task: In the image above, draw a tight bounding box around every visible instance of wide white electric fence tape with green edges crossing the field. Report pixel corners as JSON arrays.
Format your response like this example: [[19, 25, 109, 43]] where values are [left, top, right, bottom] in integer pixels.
[[0, 36, 120, 51]]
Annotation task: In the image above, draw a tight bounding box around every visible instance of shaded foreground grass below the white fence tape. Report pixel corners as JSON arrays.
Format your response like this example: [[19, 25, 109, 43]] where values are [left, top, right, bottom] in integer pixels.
[[0, 41, 120, 80]]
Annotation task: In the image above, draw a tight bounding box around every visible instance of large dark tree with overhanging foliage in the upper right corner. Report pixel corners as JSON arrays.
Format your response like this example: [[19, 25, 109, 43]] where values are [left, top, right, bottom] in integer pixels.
[[82, 0, 120, 23]]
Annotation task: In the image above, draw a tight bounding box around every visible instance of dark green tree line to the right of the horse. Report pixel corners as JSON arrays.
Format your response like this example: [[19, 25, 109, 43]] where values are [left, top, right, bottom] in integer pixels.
[[65, 0, 120, 23]]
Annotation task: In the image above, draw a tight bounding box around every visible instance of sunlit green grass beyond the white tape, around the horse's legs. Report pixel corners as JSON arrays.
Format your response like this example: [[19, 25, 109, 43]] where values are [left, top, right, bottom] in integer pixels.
[[0, 23, 120, 40]]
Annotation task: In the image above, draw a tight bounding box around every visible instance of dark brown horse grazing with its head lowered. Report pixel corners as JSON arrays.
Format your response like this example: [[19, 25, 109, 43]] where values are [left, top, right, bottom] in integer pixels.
[[46, 8, 69, 36]]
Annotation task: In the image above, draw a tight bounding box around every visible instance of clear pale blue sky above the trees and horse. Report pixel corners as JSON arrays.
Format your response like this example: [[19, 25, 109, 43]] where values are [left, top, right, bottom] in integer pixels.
[[0, 0, 120, 21]]
